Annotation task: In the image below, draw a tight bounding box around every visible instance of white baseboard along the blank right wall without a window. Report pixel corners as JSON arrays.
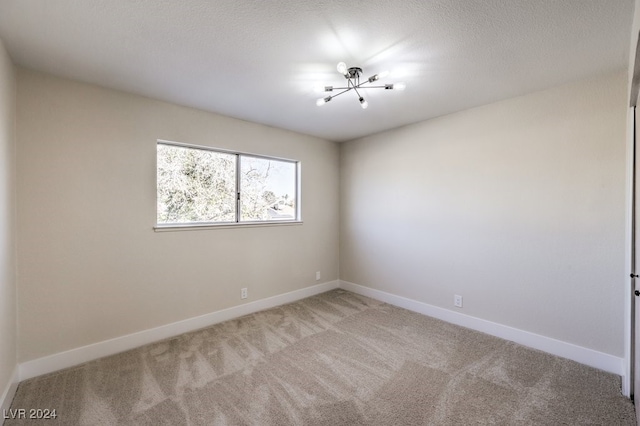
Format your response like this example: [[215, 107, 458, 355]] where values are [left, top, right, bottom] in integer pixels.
[[340, 280, 626, 382]]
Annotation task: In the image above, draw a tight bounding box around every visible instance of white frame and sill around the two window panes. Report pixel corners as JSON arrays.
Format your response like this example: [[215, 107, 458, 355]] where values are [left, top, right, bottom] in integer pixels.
[[154, 139, 303, 231]]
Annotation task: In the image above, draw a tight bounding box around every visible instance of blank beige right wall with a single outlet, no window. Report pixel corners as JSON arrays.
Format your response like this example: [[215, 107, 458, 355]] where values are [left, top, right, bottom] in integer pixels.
[[340, 73, 627, 357]]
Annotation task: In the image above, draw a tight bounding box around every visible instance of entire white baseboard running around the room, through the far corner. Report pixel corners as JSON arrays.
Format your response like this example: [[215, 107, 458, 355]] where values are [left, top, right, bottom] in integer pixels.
[[16, 281, 626, 392]]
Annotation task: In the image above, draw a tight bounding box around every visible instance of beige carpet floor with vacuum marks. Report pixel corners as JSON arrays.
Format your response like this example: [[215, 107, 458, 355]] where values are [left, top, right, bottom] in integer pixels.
[[5, 290, 635, 426]]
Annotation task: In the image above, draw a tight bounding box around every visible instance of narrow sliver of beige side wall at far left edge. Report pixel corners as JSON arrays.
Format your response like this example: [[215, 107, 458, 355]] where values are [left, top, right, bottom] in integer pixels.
[[0, 41, 17, 396]]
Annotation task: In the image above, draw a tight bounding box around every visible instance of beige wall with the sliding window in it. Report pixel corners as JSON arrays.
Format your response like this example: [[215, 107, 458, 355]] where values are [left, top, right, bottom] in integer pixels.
[[17, 69, 339, 361]]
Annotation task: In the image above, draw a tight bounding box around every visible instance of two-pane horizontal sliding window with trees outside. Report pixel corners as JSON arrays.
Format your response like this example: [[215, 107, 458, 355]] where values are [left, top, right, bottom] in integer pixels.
[[157, 142, 300, 227]]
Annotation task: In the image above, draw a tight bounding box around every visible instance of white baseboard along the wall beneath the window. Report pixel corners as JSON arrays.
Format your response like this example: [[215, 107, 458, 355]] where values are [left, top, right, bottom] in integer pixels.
[[19, 281, 338, 381]]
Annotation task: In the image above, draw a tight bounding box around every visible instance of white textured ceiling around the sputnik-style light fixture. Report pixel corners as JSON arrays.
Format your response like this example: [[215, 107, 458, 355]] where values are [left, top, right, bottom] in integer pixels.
[[0, 0, 634, 141]]
